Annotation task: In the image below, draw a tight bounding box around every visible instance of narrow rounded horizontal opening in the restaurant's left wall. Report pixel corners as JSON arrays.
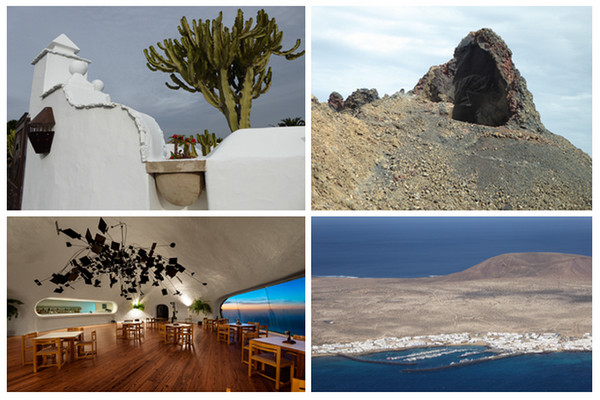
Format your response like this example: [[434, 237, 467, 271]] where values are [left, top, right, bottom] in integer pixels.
[[35, 297, 117, 317]]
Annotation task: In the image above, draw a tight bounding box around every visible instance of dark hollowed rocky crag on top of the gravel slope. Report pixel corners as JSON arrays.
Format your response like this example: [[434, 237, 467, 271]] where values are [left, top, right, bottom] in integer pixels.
[[413, 29, 545, 132]]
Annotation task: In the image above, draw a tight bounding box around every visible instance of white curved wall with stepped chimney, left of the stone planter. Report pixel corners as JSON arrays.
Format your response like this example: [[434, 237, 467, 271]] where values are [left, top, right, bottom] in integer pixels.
[[21, 35, 166, 210]]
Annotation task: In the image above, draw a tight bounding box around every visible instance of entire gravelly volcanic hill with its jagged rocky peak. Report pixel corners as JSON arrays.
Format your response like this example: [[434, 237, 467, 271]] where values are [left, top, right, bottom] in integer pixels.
[[311, 29, 592, 210]]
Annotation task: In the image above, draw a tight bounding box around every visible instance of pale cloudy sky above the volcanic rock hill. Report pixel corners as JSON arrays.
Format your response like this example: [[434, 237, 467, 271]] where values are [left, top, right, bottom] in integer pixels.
[[311, 6, 592, 155]]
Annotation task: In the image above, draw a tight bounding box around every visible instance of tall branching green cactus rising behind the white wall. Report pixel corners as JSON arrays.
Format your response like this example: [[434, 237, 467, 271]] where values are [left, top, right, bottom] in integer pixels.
[[144, 10, 304, 132]]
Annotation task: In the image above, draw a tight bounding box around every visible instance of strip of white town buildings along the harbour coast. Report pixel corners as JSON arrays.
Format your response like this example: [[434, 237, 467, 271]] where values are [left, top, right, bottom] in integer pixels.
[[311, 332, 592, 357]]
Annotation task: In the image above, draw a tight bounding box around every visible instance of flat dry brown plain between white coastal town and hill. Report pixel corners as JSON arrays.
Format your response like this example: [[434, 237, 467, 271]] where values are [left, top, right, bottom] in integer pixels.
[[312, 255, 592, 346]]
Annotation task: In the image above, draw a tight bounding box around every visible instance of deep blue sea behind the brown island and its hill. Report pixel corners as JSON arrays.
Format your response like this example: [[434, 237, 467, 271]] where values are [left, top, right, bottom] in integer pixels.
[[311, 216, 592, 278]]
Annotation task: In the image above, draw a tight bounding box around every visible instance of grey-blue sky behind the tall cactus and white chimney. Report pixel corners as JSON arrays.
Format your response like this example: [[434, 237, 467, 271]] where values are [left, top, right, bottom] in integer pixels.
[[7, 6, 306, 141]]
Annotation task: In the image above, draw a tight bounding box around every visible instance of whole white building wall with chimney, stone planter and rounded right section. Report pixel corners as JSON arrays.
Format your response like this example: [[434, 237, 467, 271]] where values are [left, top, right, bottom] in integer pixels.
[[16, 34, 306, 210]]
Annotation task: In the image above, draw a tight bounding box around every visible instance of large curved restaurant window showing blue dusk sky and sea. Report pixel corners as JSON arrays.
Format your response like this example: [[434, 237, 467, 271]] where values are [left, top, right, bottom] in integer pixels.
[[221, 278, 305, 335]]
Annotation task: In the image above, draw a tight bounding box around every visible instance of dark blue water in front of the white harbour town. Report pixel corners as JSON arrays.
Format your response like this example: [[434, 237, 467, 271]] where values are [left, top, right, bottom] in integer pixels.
[[311, 346, 592, 392]]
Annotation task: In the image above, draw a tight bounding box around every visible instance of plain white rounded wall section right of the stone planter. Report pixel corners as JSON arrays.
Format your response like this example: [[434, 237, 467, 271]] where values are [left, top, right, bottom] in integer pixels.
[[206, 127, 306, 210]]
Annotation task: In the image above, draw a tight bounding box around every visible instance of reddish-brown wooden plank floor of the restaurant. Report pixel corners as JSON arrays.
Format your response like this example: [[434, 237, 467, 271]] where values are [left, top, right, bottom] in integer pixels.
[[7, 324, 289, 392]]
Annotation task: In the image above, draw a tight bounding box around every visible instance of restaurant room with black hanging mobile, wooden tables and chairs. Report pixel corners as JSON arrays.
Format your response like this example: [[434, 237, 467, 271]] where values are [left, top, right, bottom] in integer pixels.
[[6, 216, 305, 392]]
